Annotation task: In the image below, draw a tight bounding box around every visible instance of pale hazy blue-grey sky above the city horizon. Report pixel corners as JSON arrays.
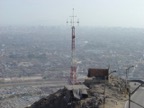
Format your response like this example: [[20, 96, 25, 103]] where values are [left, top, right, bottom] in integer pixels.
[[0, 0, 144, 28]]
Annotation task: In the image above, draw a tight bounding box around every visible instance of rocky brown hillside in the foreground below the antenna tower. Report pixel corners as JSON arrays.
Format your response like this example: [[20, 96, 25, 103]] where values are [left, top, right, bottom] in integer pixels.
[[27, 77, 127, 108]]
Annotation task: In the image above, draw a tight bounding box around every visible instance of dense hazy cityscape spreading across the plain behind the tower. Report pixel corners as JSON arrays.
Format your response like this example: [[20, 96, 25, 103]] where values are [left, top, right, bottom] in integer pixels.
[[0, 26, 144, 108]]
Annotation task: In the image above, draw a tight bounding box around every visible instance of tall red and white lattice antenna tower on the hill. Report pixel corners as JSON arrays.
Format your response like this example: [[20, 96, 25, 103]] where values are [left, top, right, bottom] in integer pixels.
[[67, 8, 79, 84]]
